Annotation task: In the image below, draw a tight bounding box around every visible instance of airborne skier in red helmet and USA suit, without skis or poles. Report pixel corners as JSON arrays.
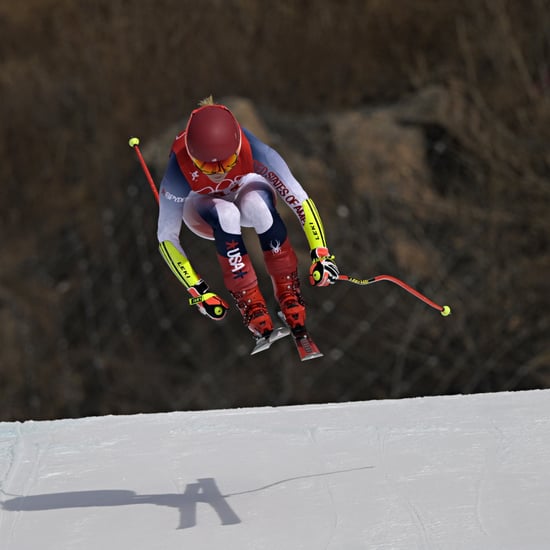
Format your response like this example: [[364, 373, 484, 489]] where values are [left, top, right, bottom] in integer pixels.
[[157, 96, 339, 352]]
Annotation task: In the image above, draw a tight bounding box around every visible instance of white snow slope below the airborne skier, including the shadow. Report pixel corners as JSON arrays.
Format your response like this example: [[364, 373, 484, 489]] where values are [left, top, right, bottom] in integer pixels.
[[0, 390, 550, 550]]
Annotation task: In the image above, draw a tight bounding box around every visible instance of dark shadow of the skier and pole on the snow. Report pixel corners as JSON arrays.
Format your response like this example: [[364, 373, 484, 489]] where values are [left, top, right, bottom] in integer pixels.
[[1, 466, 374, 529]]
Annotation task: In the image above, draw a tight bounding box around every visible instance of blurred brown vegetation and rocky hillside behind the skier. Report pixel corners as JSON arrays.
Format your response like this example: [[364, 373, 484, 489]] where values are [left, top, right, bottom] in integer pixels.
[[0, 0, 550, 420]]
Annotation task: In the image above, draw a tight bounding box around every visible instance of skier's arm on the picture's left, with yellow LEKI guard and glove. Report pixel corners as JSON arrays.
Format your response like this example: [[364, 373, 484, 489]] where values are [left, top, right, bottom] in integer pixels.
[[157, 155, 229, 320]]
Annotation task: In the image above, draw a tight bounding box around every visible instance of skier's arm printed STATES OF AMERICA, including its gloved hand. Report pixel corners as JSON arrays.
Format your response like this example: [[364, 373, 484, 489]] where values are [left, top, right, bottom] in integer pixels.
[[247, 128, 340, 286]]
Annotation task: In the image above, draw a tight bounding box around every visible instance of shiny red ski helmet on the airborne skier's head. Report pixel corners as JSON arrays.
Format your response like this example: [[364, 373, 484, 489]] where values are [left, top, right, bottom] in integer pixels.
[[185, 105, 241, 163]]
